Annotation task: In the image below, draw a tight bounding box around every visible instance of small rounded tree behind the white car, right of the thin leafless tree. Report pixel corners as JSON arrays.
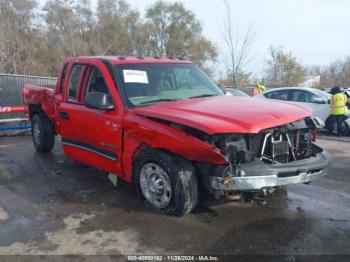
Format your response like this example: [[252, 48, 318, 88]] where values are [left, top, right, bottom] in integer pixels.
[[265, 46, 306, 87]]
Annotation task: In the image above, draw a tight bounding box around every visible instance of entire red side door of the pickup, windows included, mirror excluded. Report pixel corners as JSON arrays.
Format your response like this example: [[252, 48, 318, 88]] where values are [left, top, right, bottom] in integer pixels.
[[58, 63, 122, 175]]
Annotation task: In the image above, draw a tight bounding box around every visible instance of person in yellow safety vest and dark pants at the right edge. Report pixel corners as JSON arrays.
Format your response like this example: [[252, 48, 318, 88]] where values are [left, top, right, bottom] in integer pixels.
[[328, 86, 348, 136]]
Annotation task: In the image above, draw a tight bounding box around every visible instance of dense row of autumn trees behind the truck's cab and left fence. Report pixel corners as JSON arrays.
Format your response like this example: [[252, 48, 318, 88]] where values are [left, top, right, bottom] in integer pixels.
[[0, 0, 217, 75]]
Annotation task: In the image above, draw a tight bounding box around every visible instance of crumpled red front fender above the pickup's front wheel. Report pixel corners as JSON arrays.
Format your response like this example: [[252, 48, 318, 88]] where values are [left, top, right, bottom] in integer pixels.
[[123, 113, 227, 181]]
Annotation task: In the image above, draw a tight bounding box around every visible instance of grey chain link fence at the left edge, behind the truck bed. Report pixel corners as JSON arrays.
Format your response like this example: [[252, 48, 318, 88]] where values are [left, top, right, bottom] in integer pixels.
[[0, 74, 56, 130]]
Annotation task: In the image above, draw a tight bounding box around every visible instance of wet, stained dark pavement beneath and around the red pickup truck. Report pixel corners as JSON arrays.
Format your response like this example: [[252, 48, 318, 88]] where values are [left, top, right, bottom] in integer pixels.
[[0, 136, 350, 261]]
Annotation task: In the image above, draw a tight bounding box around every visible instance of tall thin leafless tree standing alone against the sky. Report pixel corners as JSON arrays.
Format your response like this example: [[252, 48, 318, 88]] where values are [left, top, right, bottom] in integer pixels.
[[222, 0, 256, 86]]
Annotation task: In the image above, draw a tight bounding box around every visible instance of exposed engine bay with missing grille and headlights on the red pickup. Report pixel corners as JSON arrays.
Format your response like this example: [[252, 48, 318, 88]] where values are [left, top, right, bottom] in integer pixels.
[[210, 119, 316, 166]]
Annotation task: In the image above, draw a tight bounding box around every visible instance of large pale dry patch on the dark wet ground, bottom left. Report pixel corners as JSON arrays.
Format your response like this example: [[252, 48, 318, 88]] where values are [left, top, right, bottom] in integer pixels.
[[0, 214, 164, 255]]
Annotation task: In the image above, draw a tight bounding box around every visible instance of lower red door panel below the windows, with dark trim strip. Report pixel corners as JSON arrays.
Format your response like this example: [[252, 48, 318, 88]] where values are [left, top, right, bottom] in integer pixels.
[[62, 105, 122, 175]]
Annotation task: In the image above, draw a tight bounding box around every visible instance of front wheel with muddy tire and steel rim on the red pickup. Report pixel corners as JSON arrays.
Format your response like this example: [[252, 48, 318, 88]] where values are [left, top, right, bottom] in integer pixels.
[[134, 149, 198, 216]]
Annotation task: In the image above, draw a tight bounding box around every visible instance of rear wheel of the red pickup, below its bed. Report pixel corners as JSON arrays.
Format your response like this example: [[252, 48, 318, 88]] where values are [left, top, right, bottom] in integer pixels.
[[32, 113, 55, 153]]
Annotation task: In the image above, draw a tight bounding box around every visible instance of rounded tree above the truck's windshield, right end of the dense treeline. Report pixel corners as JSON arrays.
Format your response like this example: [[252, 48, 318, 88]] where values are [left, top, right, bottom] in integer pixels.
[[145, 1, 217, 72]]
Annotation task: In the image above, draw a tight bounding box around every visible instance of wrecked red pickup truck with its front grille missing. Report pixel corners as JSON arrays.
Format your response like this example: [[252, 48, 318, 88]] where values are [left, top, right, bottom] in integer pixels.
[[23, 56, 330, 215]]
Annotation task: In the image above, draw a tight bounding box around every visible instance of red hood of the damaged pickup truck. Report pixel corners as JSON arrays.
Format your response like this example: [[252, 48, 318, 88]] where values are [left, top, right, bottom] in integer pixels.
[[135, 96, 312, 135]]
